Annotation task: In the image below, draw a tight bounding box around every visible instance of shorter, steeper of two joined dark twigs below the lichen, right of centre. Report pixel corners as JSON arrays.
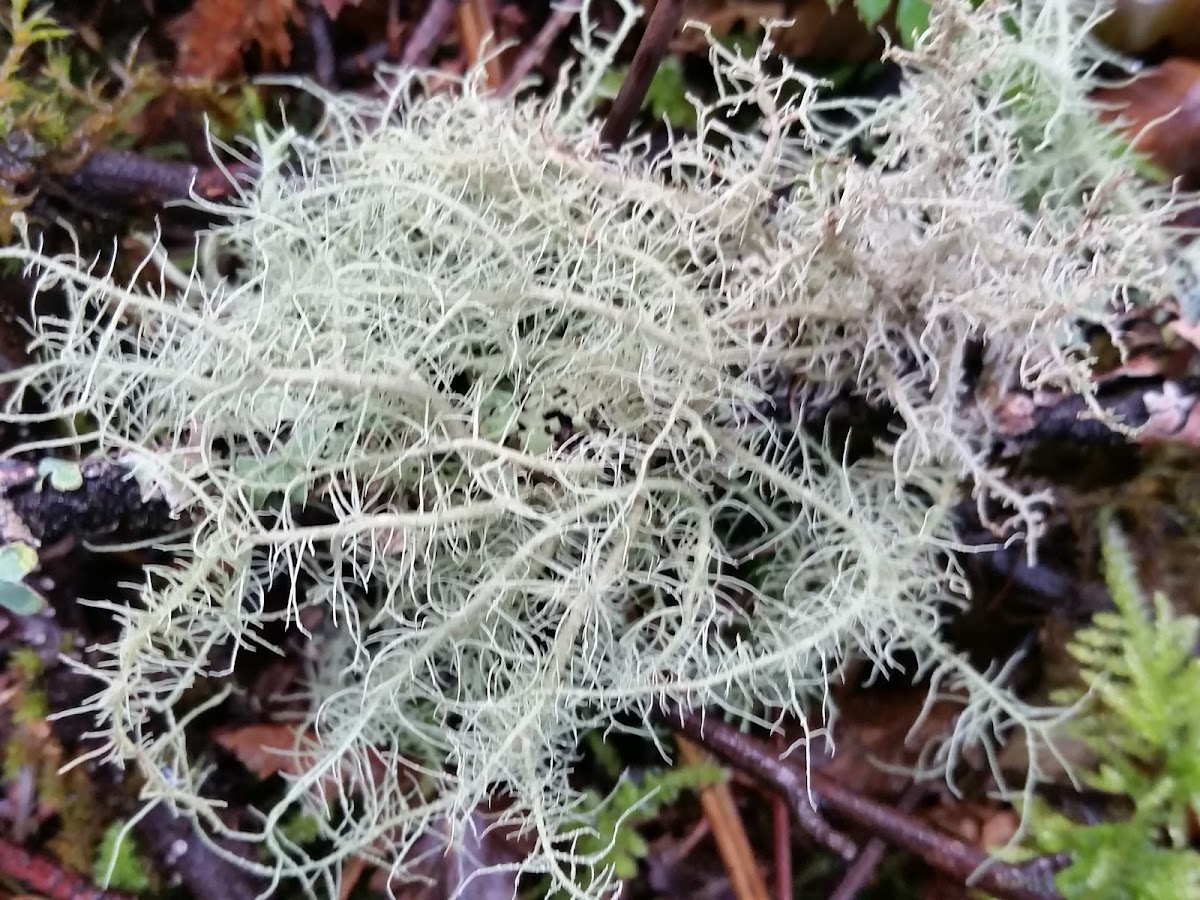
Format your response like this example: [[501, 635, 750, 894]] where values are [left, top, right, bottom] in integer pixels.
[[664, 704, 858, 859]]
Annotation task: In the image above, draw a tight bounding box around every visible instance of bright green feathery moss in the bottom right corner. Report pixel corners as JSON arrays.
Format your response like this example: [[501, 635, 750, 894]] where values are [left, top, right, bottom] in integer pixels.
[[1032, 515, 1200, 900]]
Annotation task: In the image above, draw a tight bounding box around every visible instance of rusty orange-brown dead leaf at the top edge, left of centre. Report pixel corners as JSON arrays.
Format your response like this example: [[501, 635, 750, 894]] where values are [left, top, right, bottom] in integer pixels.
[[170, 0, 299, 80]]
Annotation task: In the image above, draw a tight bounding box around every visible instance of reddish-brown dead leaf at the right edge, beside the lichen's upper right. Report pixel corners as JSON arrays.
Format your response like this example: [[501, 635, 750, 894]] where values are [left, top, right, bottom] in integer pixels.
[[1096, 59, 1200, 186]]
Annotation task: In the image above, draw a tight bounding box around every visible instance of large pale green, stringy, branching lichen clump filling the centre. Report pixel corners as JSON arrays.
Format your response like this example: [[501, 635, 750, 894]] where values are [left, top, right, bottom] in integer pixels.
[[2, 0, 1182, 896]]
